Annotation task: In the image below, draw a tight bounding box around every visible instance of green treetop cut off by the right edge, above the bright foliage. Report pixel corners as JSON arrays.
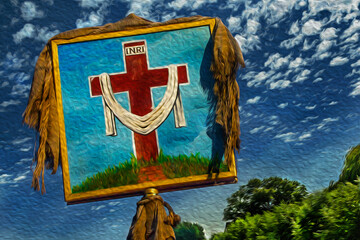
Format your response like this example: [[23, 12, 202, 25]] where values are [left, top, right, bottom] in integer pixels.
[[339, 144, 360, 183]]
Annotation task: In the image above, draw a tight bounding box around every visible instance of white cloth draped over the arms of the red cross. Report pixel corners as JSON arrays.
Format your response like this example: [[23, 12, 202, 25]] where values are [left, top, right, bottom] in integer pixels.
[[99, 65, 186, 136]]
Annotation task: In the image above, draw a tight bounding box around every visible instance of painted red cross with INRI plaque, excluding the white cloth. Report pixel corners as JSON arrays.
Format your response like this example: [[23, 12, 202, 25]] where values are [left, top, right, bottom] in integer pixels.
[[89, 41, 189, 161]]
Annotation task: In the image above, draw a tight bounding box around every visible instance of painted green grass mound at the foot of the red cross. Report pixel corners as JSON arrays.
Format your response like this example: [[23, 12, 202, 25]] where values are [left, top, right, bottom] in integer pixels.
[[72, 150, 229, 193]]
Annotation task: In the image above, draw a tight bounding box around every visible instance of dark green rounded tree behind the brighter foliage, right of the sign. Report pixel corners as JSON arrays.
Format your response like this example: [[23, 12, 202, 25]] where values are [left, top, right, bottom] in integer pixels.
[[224, 177, 308, 221]]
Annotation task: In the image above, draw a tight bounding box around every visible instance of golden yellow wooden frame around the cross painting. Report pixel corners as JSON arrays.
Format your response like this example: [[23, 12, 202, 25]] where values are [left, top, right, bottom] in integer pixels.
[[51, 19, 237, 204]]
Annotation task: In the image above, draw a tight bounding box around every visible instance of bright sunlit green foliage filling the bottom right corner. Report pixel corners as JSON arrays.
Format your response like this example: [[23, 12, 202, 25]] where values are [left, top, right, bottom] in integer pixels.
[[222, 183, 360, 240]]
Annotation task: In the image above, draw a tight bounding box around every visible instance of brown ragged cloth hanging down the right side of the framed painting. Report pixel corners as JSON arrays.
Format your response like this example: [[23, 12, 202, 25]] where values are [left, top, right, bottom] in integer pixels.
[[210, 19, 245, 170]]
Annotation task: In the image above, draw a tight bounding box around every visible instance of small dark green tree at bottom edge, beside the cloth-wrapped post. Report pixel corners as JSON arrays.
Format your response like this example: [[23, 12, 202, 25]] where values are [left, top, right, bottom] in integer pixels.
[[175, 222, 206, 240]]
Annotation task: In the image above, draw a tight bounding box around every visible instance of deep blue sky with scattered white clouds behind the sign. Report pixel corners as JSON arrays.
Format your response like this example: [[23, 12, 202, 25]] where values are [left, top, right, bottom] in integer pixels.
[[0, 0, 360, 239]]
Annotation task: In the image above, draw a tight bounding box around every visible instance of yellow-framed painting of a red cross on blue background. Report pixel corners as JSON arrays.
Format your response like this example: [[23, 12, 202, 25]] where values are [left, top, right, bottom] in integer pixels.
[[51, 19, 237, 203]]
